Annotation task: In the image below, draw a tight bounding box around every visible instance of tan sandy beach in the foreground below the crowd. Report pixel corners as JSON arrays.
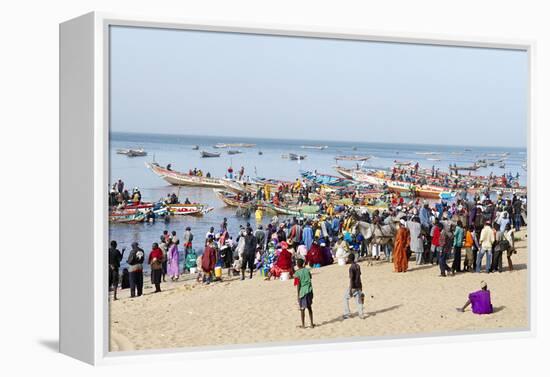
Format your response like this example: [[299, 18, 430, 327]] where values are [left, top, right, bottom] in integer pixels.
[[110, 230, 528, 351]]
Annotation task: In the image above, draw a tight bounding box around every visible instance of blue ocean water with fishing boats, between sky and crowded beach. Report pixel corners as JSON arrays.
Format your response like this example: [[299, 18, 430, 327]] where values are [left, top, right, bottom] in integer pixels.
[[109, 133, 527, 268]]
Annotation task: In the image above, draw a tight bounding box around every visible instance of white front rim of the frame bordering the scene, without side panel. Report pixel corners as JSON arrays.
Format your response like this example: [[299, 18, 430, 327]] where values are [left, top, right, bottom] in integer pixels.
[[67, 12, 537, 365]]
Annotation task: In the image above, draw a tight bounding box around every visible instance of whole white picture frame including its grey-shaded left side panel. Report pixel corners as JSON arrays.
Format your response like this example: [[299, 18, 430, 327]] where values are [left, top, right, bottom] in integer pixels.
[[60, 12, 537, 364]]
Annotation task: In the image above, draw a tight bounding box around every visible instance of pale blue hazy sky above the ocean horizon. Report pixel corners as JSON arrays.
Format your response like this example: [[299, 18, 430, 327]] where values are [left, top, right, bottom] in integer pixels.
[[111, 27, 528, 147]]
